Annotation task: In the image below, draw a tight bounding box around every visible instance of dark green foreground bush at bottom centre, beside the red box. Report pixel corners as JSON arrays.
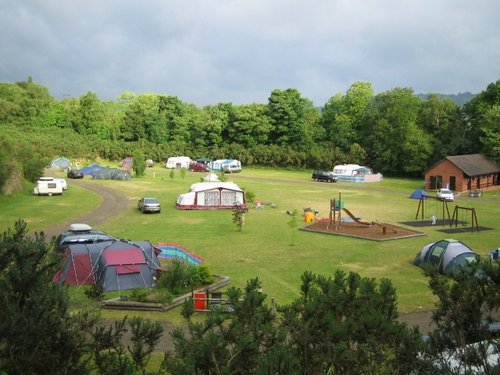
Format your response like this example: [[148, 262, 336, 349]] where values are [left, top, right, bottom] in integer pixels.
[[164, 279, 297, 375]]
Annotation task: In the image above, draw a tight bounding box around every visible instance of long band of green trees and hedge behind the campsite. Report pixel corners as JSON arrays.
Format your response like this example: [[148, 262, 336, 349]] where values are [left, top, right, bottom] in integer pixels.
[[0, 78, 500, 186]]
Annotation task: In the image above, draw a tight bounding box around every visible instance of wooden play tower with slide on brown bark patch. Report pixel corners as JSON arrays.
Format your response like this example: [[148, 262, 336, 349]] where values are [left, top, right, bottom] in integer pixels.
[[301, 193, 424, 241]]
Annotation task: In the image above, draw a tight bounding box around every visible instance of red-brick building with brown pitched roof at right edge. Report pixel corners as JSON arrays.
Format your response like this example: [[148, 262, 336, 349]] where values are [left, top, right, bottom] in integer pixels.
[[424, 154, 500, 192]]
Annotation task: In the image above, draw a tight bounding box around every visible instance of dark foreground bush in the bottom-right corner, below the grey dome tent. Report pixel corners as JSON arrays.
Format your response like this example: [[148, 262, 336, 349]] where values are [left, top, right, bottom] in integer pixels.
[[421, 260, 500, 374]]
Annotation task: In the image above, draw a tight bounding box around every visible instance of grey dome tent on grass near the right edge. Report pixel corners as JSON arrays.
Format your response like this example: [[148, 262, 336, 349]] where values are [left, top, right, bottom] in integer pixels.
[[413, 239, 478, 275]]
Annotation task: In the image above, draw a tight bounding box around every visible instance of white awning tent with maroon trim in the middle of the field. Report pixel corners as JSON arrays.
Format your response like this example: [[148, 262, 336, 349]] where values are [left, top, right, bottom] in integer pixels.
[[176, 181, 246, 210]]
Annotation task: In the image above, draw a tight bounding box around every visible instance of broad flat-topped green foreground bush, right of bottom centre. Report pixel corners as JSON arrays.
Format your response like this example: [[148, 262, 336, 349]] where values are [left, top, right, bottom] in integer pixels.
[[283, 271, 421, 375]]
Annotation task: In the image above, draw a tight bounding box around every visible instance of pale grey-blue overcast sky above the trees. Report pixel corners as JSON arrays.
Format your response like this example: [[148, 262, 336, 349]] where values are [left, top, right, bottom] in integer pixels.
[[0, 0, 500, 106]]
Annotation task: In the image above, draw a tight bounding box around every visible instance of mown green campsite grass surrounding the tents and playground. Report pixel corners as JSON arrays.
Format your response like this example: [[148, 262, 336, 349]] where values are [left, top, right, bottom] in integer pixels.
[[0, 167, 500, 320]]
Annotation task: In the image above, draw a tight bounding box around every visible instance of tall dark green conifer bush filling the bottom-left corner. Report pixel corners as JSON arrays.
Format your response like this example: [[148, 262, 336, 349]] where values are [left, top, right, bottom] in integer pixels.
[[0, 221, 95, 374]]
